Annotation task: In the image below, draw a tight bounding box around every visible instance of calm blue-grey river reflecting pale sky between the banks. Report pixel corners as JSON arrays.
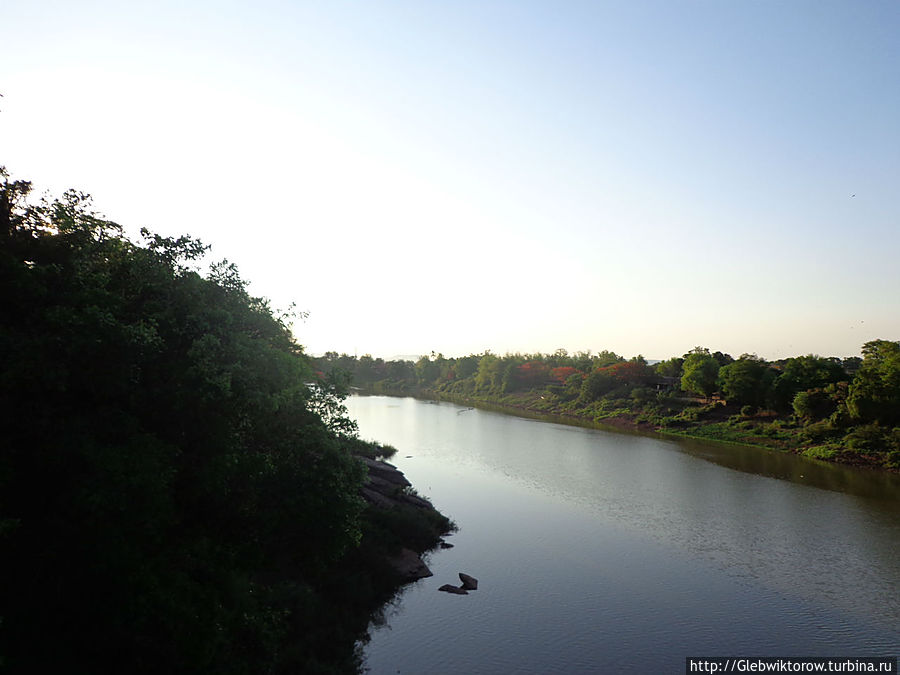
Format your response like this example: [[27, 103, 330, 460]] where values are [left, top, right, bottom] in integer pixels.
[[348, 396, 900, 674]]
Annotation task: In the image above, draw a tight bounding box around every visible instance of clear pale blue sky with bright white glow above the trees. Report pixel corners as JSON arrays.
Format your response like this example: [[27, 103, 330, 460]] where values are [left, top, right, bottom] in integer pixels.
[[0, 0, 900, 359]]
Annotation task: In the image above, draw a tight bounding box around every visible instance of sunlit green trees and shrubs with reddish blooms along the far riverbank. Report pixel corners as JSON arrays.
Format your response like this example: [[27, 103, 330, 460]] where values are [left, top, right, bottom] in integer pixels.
[[314, 340, 900, 470]]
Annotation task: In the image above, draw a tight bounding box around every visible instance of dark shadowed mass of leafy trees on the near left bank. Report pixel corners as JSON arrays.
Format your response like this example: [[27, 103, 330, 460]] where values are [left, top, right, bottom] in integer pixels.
[[0, 171, 442, 673]]
